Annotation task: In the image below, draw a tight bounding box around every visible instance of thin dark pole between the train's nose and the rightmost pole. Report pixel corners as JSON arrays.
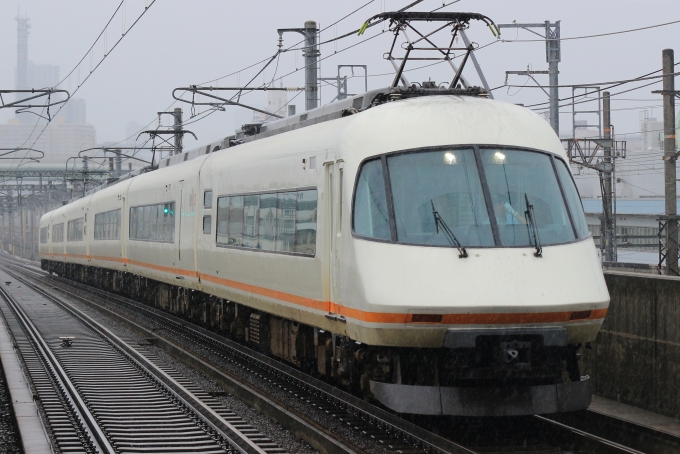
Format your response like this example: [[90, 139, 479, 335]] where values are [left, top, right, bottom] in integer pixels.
[[600, 91, 616, 262]]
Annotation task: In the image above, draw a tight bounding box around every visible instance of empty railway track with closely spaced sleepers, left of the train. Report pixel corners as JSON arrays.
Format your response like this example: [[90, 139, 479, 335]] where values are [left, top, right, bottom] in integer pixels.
[[0, 264, 285, 454]]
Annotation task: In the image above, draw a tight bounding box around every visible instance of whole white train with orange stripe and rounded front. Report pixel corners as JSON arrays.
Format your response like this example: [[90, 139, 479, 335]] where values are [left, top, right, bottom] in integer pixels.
[[40, 88, 609, 416]]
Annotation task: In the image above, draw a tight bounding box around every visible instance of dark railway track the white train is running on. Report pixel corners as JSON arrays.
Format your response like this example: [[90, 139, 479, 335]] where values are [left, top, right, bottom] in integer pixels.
[[1, 263, 668, 453]]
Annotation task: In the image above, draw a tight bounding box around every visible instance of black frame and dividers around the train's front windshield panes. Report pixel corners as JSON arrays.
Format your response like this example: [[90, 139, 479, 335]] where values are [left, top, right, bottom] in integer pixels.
[[349, 143, 592, 249]]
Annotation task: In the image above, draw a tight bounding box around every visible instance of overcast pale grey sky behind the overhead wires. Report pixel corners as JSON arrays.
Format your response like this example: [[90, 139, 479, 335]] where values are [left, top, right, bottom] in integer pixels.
[[0, 0, 680, 154]]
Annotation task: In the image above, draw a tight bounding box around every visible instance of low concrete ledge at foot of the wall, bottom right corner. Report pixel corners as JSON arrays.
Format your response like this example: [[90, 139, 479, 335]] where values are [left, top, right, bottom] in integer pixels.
[[588, 396, 680, 438]]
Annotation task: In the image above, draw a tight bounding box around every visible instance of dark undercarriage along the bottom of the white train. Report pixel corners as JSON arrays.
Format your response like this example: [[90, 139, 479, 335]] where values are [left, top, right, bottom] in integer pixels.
[[41, 260, 590, 416]]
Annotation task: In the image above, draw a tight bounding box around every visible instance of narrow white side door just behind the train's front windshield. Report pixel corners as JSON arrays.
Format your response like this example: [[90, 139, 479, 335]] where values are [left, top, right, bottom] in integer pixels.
[[324, 161, 344, 320]]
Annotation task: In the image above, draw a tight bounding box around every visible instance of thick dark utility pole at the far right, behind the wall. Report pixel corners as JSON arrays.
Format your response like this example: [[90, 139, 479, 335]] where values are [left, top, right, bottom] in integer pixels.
[[662, 49, 680, 276]]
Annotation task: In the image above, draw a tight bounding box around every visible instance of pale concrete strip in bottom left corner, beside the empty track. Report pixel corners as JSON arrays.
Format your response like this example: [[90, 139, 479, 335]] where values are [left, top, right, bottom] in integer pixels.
[[0, 314, 53, 454]]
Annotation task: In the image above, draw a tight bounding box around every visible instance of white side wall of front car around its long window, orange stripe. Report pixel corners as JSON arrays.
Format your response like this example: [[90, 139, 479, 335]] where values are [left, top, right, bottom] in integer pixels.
[[198, 119, 348, 334]]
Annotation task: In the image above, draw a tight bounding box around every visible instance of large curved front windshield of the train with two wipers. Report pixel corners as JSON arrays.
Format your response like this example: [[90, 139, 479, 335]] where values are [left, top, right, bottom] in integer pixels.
[[353, 147, 588, 247]]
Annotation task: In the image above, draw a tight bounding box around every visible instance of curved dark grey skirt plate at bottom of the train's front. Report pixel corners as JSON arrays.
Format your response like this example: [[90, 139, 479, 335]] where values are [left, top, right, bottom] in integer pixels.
[[370, 377, 591, 417]]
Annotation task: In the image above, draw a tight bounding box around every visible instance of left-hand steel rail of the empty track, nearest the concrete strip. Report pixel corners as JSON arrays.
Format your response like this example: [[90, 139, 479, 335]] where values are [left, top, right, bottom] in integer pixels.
[[0, 287, 116, 454]]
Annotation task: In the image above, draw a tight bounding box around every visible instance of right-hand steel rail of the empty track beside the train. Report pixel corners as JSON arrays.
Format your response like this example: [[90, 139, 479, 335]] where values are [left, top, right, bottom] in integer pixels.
[[2, 270, 266, 454]]
